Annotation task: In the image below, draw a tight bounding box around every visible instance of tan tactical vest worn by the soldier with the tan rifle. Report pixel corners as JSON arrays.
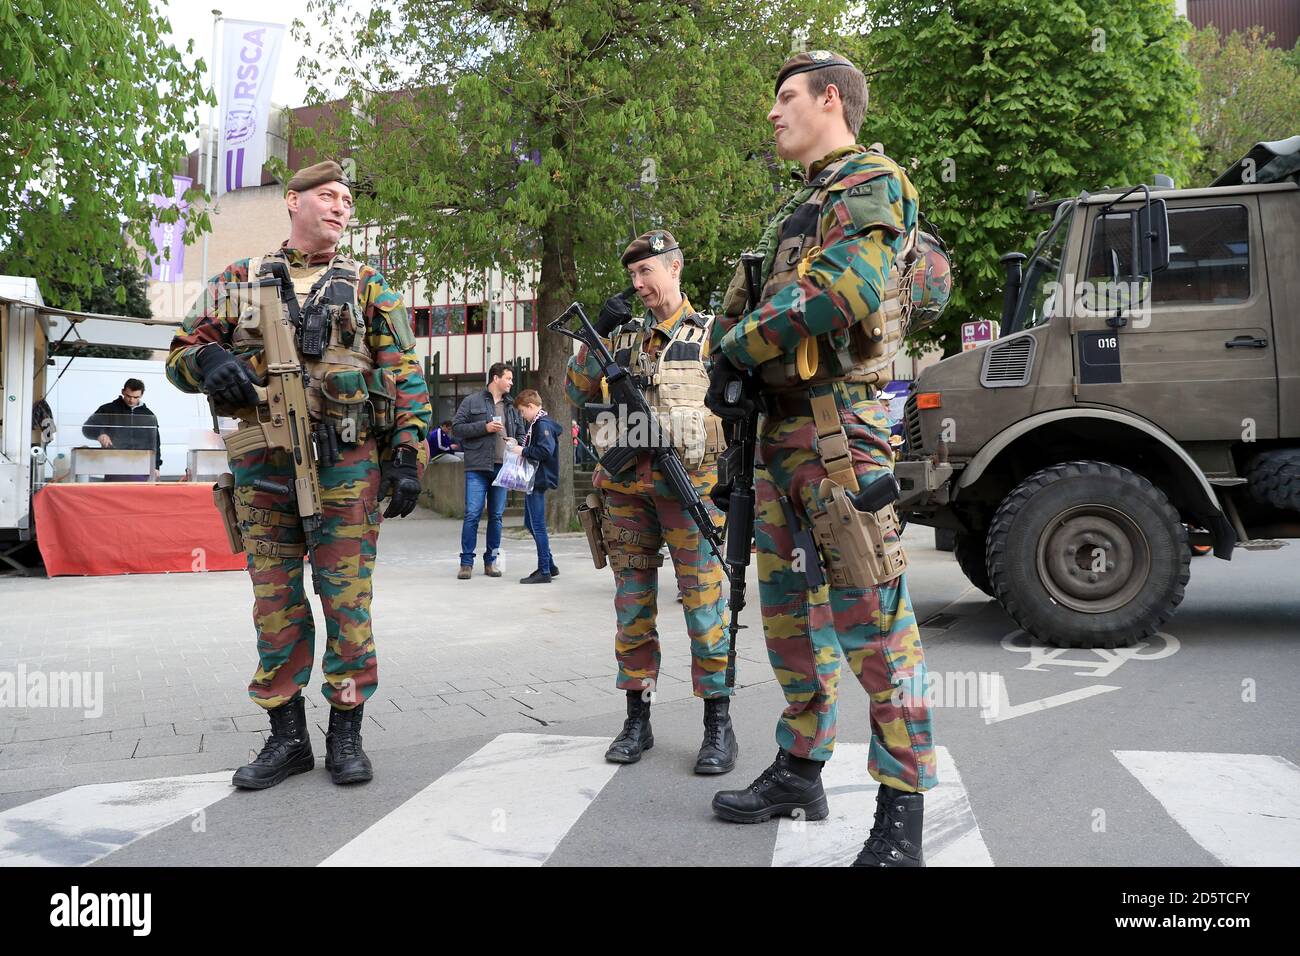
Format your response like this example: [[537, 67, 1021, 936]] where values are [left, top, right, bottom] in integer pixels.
[[231, 252, 397, 444]]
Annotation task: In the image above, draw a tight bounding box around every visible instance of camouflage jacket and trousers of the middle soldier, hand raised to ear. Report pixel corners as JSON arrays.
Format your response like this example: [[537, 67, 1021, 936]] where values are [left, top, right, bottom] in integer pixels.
[[566, 298, 731, 698]]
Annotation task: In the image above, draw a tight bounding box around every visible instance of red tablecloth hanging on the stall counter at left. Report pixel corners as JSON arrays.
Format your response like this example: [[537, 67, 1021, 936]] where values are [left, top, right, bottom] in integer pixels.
[[33, 481, 247, 576]]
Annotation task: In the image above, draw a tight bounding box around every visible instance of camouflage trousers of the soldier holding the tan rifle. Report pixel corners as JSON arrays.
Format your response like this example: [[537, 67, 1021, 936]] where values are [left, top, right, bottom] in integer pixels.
[[231, 440, 381, 710]]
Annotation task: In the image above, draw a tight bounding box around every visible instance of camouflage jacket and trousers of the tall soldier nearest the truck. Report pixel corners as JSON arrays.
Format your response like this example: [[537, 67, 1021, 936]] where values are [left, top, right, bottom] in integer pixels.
[[714, 146, 936, 792]]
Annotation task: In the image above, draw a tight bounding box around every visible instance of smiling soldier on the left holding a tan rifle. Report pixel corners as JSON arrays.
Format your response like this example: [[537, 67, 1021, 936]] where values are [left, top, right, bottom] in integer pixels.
[[166, 163, 432, 790]]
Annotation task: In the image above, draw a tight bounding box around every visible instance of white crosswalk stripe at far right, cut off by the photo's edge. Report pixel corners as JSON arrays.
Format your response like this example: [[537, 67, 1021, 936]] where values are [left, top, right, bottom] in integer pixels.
[[1113, 750, 1300, 866]]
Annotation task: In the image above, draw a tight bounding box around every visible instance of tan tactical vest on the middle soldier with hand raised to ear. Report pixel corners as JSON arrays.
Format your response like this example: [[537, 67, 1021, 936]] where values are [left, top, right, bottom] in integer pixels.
[[592, 313, 725, 470]]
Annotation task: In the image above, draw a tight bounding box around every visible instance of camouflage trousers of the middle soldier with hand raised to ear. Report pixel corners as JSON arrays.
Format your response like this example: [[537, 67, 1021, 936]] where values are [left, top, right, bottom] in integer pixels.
[[605, 489, 731, 697]]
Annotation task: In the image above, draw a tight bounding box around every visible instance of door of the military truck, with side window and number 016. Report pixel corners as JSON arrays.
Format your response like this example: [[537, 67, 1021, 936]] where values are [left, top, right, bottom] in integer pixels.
[[1071, 194, 1278, 441]]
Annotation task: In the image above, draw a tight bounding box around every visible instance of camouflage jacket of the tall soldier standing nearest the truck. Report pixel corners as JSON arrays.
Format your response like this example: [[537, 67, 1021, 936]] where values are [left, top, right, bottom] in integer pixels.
[[712, 146, 918, 368]]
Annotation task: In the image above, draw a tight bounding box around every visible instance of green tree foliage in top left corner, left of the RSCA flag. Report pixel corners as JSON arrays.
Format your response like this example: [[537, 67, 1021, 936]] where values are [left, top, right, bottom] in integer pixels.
[[0, 0, 209, 308]]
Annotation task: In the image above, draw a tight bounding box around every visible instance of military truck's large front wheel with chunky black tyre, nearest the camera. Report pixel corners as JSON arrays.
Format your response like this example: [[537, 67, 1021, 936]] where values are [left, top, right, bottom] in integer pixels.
[[985, 462, 1191, 648]]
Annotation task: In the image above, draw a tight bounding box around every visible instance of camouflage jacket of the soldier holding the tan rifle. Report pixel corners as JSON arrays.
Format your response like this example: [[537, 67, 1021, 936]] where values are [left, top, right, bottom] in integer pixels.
[[166, 248, 433, 463]]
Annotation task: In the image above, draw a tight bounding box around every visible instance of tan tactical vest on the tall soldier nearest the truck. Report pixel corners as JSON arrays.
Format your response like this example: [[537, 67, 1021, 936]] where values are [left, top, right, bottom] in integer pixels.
[[723, 143, 917, 392]]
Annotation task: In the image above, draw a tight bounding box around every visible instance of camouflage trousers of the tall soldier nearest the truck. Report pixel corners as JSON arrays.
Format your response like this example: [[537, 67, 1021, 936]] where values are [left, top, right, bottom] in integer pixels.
[[754, 384, 936, 791]]
